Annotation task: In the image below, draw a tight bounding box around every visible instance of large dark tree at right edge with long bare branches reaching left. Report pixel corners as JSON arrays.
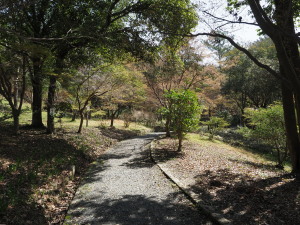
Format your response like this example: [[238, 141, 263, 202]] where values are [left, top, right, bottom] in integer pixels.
[[192, 0, 300, 173]]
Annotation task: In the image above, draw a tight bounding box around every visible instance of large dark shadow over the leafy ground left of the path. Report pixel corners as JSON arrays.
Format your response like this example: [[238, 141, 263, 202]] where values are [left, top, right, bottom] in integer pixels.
[[0, 127, 89, 225]]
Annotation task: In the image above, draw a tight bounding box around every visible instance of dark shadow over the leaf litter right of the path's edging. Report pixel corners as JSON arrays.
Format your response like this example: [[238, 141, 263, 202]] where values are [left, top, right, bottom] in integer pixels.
[[190, 169, 300, 225]]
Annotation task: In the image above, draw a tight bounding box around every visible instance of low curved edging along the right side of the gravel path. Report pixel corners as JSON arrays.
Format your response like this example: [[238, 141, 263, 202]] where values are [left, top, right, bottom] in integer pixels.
[[148, 135, 232, 225]]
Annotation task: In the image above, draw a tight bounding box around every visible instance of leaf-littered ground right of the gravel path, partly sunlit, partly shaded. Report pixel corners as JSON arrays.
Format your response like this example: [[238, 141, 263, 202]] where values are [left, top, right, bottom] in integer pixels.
[[153, 134, 300, 225]]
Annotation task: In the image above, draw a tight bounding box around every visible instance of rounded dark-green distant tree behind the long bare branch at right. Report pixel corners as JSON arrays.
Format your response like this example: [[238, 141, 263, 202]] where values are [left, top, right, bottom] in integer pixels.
[[221, 39, 281, 124]]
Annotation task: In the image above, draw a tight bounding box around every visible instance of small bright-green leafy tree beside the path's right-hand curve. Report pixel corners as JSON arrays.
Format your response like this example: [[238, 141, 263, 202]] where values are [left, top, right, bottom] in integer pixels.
[[162, 90, 201, 151]]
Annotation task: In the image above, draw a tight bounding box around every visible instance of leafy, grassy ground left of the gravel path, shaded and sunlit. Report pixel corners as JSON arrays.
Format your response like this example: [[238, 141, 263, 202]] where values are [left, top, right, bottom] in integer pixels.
[[0, 121, 150, 225]]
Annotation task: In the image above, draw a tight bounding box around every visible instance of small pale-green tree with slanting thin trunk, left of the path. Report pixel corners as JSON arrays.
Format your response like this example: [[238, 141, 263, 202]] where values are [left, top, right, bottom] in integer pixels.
[[65, 58, 133, 133]]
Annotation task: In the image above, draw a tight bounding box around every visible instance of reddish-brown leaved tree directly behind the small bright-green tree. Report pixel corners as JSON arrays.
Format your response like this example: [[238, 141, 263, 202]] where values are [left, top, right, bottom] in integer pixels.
[[144, 42, 204, 137]]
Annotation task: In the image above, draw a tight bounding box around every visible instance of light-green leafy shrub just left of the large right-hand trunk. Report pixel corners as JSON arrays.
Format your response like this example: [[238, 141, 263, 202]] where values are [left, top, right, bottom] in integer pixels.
[[244, 103, 287, 167]]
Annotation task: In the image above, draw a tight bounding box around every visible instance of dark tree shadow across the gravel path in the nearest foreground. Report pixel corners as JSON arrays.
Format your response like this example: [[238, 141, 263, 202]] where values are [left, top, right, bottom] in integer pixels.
[[65, 194, 208, 225]]
